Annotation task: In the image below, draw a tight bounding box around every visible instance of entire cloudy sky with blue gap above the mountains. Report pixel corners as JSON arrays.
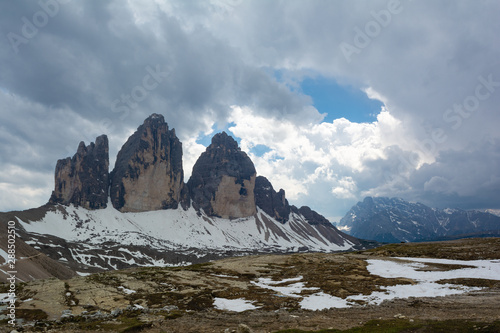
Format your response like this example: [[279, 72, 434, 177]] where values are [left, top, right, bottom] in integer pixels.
[[0, 0, 500, 221]]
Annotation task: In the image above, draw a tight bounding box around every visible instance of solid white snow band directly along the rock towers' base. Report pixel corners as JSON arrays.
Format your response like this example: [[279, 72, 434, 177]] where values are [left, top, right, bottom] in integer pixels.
[[19, 201, 353, 252]]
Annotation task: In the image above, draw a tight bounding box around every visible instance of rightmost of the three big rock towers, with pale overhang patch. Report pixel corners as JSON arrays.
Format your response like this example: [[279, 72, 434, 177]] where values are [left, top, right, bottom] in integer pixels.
[[187, 132, 256, 218]]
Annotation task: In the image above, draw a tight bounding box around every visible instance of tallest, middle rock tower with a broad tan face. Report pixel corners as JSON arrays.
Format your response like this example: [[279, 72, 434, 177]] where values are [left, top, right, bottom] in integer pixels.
[[110, 114, 185, 212]]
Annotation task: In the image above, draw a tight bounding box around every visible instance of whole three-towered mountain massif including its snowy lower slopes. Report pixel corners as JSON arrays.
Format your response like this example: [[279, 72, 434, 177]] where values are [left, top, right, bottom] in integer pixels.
[[0, 114, 373, 280]]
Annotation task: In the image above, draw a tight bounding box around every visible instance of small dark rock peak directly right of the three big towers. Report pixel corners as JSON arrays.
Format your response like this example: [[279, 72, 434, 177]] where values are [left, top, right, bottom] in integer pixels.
[[255, 176, 290, 223]]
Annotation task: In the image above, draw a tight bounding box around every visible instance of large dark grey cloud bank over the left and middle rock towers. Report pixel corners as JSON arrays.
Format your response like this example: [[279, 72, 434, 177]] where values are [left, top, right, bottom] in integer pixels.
[[0, 0, 316, 210]]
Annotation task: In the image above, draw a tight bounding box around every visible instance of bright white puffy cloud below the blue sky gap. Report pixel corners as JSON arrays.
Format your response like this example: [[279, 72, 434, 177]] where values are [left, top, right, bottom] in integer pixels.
[[229, 106, 418, 214]]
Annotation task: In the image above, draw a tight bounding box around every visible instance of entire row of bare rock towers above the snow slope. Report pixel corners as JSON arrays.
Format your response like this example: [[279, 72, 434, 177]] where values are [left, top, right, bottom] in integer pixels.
[[46, 114, 348, 237]]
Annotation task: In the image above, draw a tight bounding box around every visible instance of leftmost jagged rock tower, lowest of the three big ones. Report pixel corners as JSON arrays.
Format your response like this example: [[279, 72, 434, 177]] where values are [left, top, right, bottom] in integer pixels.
[[49, 135, 109, 209]]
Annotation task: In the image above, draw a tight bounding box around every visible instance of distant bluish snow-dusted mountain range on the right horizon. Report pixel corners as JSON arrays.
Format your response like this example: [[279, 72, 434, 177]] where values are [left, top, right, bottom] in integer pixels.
[[337, 197, 500, 243]]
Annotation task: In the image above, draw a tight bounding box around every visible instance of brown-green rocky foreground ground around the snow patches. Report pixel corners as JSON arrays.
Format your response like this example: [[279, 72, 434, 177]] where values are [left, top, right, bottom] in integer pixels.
[[0, 238, 500, 332]]
